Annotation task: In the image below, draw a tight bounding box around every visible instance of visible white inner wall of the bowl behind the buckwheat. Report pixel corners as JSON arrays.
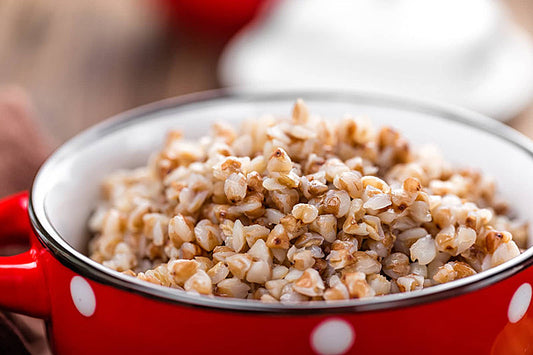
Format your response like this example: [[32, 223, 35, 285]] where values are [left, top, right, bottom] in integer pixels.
[[32, 93, 533, 308]]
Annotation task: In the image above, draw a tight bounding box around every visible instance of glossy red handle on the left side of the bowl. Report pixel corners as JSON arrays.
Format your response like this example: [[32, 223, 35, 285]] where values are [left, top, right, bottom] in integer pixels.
[[0, 192, 50, 318]]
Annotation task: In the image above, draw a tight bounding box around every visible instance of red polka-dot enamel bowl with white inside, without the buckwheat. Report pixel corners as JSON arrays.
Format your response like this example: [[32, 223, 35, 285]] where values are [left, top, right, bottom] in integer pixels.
[[0, 92, 533, 354]]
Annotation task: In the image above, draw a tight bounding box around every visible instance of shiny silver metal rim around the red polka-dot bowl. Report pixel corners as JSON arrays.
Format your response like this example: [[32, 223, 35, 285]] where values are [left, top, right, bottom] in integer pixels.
[[28, 88, 533, 314]]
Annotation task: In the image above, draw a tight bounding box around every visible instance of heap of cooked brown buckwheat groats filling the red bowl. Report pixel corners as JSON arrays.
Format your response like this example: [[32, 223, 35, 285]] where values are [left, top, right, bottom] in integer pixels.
[[88, 100, 528, 302]]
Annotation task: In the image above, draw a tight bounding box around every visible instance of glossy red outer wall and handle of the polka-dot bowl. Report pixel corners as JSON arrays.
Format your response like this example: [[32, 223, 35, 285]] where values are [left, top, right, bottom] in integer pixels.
[[0, 194, 533, 355]]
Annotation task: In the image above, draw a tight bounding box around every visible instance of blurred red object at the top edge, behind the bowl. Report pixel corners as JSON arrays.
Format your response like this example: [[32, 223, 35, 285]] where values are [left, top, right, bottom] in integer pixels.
[[159, 0, 268, 38]]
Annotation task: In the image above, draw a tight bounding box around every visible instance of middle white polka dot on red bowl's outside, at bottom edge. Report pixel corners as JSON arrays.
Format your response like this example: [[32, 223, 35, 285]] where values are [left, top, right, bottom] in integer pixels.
[[311, 318, 355, 355]]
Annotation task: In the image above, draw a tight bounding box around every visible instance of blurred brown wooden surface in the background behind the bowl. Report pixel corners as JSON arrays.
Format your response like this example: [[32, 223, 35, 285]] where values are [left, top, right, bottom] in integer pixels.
[[0, 0, 533, 353]]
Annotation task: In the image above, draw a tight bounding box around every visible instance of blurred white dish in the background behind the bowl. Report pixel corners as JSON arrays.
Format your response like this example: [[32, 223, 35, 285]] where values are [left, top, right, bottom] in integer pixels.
[[219, 0, 533, 120]]
